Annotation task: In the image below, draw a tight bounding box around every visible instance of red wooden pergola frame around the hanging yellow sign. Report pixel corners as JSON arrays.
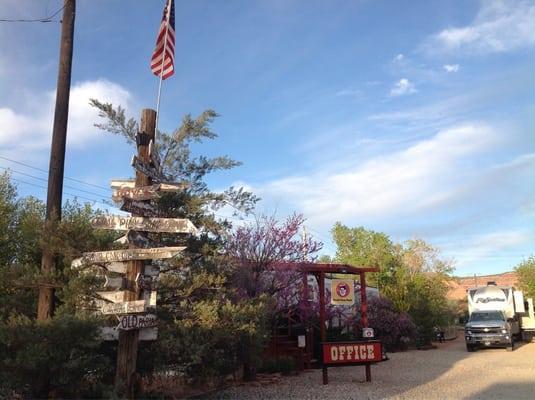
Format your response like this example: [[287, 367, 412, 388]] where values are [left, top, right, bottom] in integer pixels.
[[272, 262, 379, 385]]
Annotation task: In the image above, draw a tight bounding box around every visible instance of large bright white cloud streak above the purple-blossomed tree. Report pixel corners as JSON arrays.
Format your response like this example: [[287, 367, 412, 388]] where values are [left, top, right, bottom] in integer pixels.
[[255, 123, 500, 227]]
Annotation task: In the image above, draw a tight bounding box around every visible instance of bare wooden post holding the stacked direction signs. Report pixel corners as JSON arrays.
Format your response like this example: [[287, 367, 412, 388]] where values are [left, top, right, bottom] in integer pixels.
[[115, 109, 156, 399]]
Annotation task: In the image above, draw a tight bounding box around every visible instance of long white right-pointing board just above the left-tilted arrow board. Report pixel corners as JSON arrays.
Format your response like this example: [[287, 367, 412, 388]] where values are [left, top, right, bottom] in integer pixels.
[[91, 215, 197, 234]]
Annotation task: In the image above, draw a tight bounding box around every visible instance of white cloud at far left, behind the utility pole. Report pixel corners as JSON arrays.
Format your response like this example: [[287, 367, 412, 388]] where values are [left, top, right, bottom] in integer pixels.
[[0, 80, 131, 156]]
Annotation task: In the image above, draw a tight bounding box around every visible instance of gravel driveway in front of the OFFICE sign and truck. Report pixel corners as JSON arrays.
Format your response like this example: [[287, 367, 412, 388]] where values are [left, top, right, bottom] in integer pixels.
[[208, 336, 535, 400]]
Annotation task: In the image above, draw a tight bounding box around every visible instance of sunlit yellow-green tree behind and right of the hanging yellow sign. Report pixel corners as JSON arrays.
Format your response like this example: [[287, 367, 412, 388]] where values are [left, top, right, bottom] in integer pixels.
[[332, 223, 455, 343]]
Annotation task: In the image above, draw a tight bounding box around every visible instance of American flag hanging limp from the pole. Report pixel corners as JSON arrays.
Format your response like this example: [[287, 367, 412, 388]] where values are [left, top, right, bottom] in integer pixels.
[[150, 0, 175, 79]]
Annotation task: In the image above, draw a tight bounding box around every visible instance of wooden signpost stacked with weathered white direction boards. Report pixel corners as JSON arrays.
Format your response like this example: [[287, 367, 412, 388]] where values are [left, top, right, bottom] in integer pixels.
[[72, 109, 196, 398]]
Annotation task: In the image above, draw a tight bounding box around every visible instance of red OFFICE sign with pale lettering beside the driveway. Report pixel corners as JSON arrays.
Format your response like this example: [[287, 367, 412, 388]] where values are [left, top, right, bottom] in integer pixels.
[[323, 342, 383, 364]]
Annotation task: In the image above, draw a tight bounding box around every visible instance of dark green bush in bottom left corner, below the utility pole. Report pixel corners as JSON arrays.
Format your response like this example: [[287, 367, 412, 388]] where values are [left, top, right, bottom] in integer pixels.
[[0, 315, 112, 398]]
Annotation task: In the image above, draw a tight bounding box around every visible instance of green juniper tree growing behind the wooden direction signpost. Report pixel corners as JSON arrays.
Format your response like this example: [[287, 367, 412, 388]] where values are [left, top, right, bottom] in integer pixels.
[[91, 100, 269, 381]]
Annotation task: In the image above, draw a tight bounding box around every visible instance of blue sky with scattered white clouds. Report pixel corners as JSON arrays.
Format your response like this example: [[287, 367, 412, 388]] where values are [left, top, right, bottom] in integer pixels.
[[0, 0, 535, 276]]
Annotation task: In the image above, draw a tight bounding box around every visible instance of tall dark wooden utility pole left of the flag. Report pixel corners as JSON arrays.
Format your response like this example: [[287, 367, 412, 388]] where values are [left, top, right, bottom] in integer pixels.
[[37, 0, 76, 320]]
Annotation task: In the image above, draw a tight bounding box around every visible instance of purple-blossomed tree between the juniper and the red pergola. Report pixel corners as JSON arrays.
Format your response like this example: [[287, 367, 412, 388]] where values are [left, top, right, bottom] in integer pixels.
[[225, 214, 321, 380]]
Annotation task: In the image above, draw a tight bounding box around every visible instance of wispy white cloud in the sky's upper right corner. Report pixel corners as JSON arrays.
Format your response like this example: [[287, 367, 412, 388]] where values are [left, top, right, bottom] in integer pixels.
[[430, 0, 535, 54]]
